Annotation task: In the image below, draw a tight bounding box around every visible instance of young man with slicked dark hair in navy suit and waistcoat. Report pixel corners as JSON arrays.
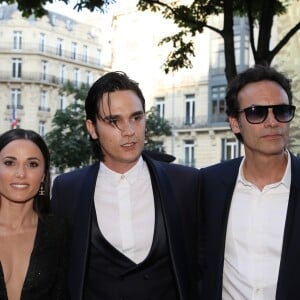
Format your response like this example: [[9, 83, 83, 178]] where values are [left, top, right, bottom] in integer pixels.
[[51, 72, 199, 300]]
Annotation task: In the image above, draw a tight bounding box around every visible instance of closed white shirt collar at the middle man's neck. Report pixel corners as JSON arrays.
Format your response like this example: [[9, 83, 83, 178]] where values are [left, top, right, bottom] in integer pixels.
[[99, 156, 146, 185]]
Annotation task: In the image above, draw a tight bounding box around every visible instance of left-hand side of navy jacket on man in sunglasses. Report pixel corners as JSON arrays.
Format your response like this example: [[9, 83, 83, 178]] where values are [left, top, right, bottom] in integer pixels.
[[199, 158, 242, 299]]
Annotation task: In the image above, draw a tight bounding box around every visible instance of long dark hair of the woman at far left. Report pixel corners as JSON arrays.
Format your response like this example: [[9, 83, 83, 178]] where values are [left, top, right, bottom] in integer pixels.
[[0, 128, 51, 217]]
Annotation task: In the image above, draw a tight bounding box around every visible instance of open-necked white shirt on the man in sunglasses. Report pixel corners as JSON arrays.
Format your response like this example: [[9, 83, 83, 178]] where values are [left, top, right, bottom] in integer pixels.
[[222, 155, 291, 300]]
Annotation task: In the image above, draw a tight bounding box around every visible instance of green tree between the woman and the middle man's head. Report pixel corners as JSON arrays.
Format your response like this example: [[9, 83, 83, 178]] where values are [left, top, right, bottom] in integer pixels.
[[45, 83, 93, 172]]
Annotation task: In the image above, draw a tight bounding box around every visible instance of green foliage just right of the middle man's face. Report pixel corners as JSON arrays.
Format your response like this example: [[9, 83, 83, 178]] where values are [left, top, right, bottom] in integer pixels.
[[145, 107, 172, 152]]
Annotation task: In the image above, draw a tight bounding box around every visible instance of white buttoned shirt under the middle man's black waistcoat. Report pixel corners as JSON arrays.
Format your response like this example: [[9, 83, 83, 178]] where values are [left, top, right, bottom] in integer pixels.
[[94, 158, 155, 263]]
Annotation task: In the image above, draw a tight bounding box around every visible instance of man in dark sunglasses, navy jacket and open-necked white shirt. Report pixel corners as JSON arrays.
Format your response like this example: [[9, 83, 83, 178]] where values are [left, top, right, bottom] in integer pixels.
[[200, 66, 300, 300]]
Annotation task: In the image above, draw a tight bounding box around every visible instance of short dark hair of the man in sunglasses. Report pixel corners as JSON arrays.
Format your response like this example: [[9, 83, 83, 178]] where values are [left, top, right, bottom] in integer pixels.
[[225, 65, 293, 141]]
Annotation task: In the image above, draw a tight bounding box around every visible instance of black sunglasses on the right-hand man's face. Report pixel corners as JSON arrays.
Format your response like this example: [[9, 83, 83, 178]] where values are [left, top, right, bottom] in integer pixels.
[[238, 104, 296, 124]]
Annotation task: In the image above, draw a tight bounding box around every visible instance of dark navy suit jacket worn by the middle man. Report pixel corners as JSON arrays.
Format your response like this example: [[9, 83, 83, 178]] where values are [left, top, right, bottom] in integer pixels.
[[51, 154, 199, 300]]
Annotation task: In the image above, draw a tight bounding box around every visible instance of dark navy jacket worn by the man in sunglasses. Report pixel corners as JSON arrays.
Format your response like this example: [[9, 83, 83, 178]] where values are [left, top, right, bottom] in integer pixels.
[[200, 155, 300, 300]]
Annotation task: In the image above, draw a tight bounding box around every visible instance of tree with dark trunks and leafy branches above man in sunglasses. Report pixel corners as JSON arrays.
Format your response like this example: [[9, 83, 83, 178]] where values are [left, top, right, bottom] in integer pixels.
[[138, 0, 300, 81]]
